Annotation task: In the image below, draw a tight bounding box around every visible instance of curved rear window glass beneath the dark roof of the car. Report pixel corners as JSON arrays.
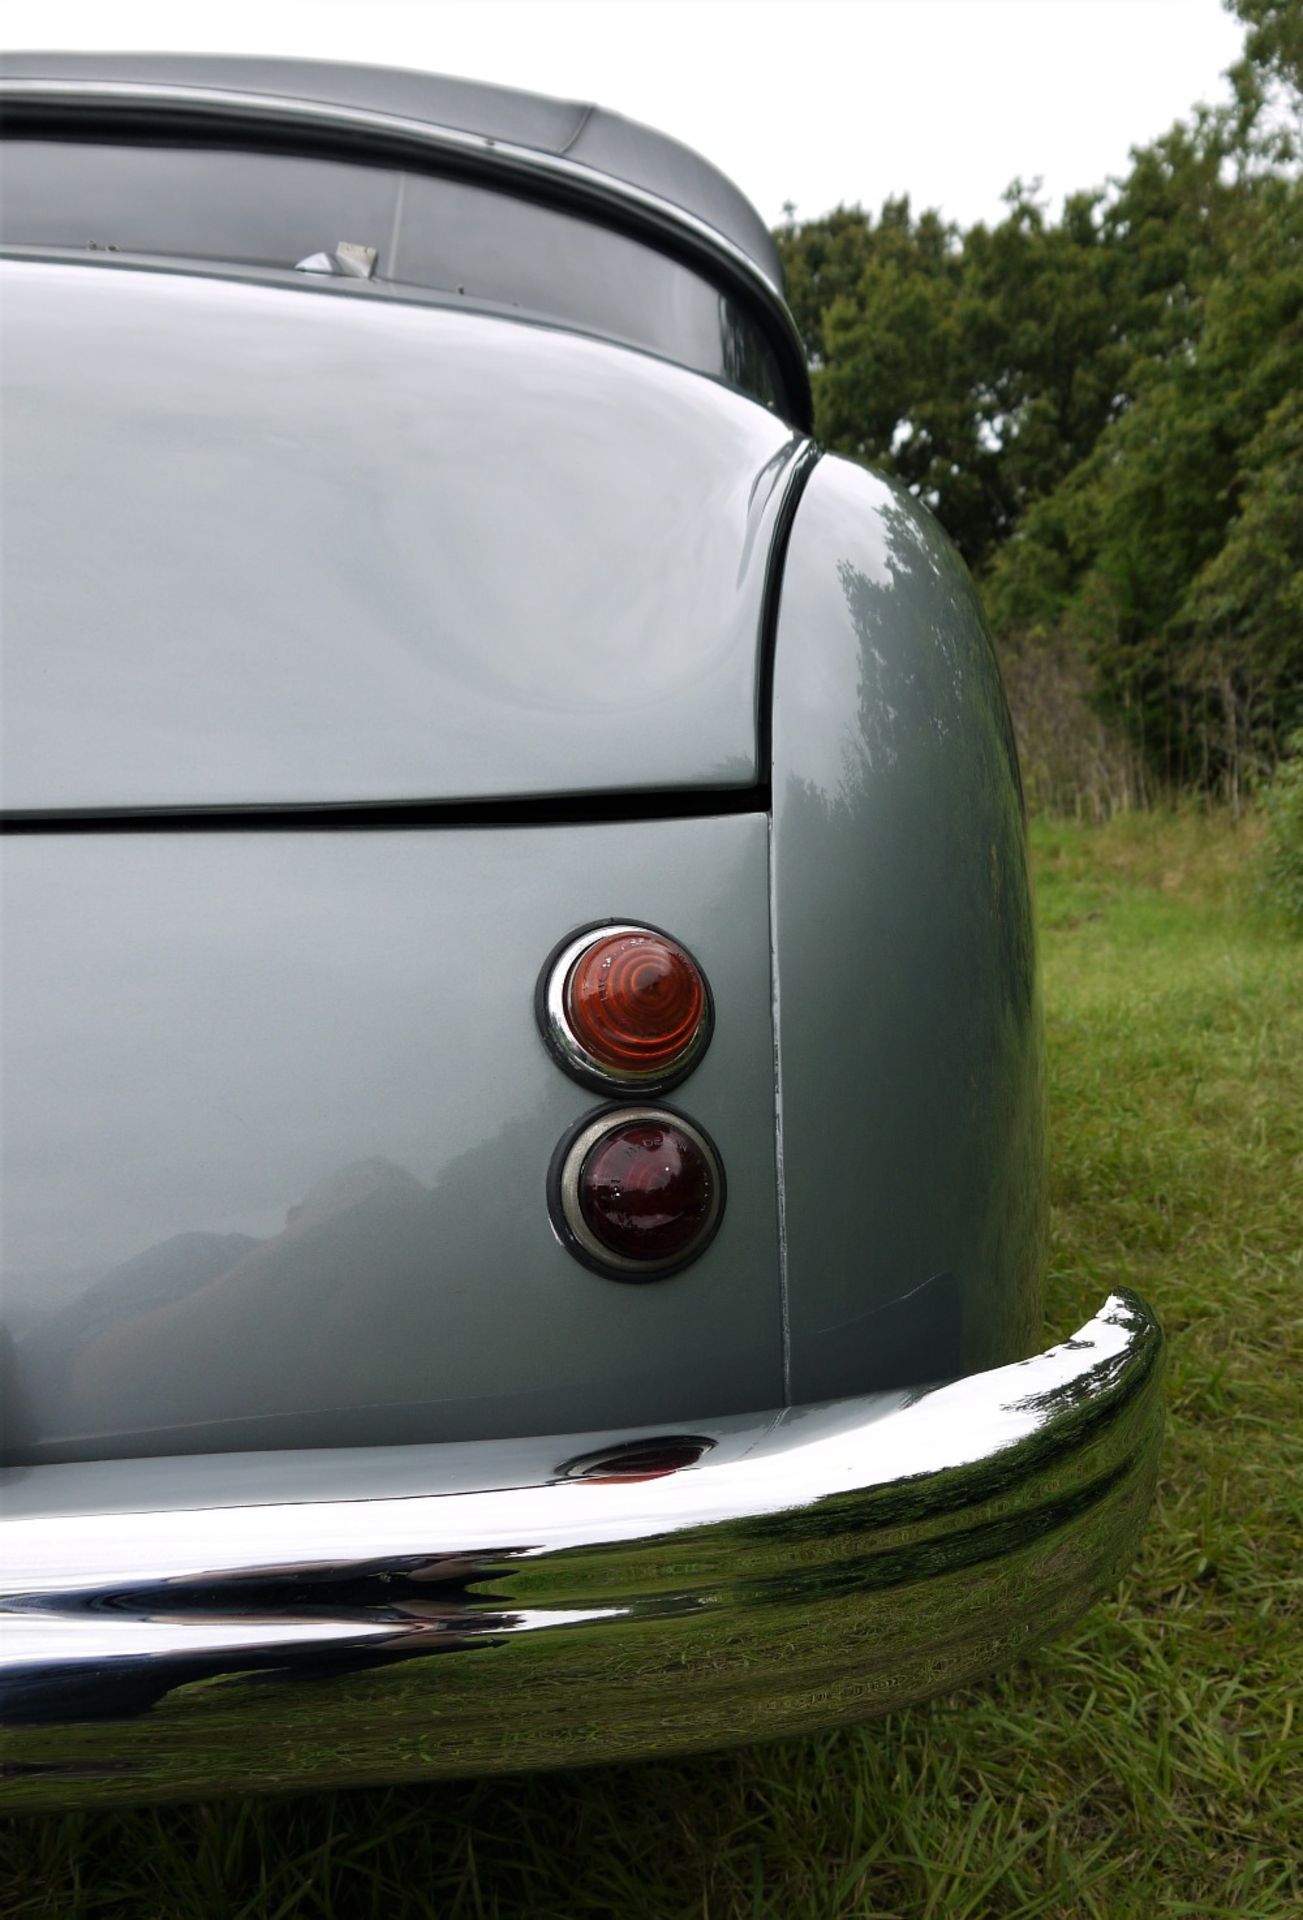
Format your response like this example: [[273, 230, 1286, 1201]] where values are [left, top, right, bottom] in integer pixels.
[[0, 138, 791, 417]]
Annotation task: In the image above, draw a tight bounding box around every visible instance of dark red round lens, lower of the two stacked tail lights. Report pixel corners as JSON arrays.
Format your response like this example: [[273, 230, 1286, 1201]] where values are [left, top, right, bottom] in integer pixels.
[[578, 1119, 720, 1263]]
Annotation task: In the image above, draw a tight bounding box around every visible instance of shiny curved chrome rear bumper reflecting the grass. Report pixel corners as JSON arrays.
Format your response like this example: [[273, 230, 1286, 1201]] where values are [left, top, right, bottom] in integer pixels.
[[0, 1292, 1163, 1811]]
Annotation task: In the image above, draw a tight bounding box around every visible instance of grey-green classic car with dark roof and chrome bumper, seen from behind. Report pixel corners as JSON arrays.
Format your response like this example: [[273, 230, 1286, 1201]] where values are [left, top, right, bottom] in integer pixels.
[[0, 56, 1161, 1809]]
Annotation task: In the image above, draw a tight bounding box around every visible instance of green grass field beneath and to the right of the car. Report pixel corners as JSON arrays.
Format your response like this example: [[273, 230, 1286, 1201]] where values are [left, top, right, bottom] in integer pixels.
[[0, 814, 1303, 1920]]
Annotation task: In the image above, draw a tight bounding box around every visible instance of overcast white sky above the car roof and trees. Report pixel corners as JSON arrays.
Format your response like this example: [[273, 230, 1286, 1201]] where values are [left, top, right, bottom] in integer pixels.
[[0, 0, 1242, 223]]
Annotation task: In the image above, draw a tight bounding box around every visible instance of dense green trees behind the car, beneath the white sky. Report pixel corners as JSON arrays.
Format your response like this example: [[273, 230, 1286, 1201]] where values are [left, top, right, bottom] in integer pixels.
[[777, 0, 1303, 810]]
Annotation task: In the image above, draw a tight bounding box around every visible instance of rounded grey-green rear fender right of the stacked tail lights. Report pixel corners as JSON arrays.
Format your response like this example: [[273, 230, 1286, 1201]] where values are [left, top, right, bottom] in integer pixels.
[[771, 459, 1044, 1404]]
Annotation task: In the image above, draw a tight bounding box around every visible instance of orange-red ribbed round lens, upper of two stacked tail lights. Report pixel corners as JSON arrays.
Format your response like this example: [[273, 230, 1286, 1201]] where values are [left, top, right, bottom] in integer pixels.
[[566, 929, 706, 1075]]
